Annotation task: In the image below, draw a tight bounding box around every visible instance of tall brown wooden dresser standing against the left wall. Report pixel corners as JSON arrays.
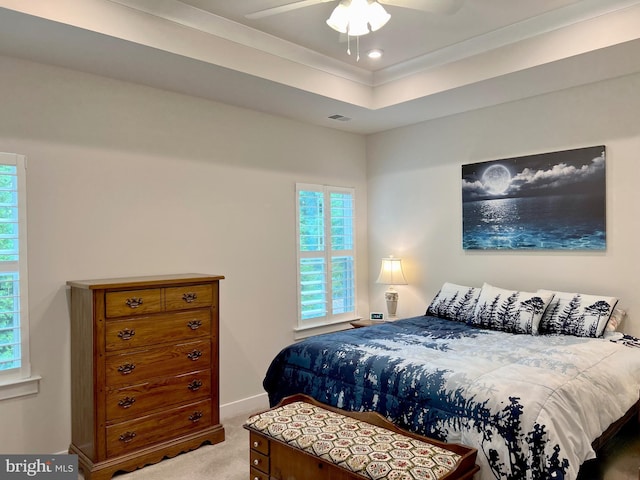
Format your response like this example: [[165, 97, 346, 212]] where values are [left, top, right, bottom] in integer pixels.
[[67, 274, 224, 480]]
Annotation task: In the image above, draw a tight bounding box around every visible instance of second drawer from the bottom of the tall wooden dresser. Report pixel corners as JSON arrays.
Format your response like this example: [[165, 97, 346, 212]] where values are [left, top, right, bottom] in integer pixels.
[[107, 370, 211, 422]]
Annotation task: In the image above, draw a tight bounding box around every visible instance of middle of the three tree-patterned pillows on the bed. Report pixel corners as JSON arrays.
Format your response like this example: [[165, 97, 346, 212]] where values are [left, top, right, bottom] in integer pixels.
[[470, 283, 553, 335]]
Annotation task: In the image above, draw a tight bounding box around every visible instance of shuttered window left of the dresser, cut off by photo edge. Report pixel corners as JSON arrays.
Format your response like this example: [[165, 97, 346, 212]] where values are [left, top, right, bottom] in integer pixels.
[[0, 153, 37, 398]]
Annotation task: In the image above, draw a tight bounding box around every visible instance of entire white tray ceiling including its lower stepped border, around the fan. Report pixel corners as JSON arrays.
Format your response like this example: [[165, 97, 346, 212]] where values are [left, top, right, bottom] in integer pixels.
[[0, 0, 640, 134]]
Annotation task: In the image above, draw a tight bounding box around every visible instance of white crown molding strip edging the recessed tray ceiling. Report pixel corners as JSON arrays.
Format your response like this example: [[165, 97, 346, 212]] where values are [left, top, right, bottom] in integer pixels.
[[109, 0, 640, 87]]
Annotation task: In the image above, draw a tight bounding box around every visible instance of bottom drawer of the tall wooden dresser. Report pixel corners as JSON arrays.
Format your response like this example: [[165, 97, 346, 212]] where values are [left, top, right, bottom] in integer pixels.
[[107, 400, 211, 457]]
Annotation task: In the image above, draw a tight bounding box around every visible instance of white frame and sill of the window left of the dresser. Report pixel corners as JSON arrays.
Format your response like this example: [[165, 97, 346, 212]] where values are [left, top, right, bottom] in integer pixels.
[[0, 152, 40, 400]]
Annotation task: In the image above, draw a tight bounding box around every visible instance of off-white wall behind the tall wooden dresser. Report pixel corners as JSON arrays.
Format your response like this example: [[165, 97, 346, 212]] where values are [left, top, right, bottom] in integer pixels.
[[0, 57, 368, 453]]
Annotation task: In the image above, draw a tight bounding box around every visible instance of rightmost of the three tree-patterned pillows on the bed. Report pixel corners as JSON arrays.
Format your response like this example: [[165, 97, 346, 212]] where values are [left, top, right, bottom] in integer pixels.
[[538, 290, 618, 338]]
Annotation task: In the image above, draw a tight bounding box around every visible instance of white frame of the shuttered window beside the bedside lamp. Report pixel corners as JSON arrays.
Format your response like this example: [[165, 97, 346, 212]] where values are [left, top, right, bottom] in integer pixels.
[[295, 183, 360, 331]]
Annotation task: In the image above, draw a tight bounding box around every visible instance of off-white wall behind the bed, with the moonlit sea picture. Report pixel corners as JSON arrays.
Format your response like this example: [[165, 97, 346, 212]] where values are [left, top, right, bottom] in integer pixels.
[[367, 75, 640, 335]]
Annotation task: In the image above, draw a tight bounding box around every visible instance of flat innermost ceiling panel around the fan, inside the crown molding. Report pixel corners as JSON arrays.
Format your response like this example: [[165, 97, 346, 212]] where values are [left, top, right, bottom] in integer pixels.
[[176, 0, 579, 71]]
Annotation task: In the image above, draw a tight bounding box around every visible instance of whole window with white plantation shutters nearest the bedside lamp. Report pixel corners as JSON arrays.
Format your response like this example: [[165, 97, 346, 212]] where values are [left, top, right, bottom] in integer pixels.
[[296, 184, 356, 328]]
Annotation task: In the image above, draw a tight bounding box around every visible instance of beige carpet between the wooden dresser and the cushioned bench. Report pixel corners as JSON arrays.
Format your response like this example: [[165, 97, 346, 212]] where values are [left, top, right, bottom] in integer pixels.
[[78, 415, 249, 480]]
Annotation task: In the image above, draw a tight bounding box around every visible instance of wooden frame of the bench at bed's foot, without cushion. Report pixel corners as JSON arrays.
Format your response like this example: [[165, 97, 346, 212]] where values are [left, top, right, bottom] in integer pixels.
[[245, 395, 480, 480]]
